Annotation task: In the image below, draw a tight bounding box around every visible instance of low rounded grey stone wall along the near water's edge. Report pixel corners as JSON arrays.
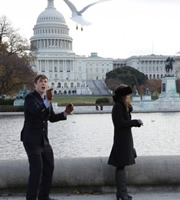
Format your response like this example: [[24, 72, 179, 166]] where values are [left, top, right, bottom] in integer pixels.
[[0, 156, 180, 192]]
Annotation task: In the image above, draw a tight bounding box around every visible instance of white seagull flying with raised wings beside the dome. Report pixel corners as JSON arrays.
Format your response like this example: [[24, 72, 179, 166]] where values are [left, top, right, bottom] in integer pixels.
[[64, 0, 108, 31]]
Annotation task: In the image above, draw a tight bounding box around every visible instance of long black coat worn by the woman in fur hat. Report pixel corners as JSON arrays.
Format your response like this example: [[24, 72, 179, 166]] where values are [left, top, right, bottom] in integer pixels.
[[108, 102, 136, 167]]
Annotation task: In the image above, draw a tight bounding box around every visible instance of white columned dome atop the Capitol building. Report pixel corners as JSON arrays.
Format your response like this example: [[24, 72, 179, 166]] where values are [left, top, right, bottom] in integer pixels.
[[31, 0, 73, 53]]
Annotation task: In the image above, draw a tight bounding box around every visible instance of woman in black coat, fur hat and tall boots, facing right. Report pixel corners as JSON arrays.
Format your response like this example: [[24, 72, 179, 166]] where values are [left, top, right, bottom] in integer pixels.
[[108, 84, 143, 200]]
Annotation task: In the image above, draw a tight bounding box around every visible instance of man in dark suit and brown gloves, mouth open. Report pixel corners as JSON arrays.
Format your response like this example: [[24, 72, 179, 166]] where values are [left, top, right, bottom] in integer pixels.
[[21, 74, 73, 200]]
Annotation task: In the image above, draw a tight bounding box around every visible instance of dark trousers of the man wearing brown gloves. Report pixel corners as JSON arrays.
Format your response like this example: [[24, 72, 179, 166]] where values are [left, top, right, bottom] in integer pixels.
[[24, 143, 54, 200]]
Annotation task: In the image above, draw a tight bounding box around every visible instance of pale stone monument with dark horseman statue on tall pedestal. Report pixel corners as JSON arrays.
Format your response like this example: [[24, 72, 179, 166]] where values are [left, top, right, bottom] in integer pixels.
[[132, 57, 180, 112]]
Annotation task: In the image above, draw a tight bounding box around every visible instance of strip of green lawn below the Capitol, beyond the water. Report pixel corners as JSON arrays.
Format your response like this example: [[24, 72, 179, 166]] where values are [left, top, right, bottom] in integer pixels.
[[53, 96, 111, 105]]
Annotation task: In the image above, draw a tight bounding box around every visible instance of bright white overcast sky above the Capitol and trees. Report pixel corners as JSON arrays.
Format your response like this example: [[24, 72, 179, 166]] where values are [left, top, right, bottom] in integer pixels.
[[0, 0, 180, 58]]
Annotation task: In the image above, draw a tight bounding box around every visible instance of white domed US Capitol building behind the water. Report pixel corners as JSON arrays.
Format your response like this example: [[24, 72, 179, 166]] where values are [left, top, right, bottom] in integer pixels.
[[30, 0, 179, 95]]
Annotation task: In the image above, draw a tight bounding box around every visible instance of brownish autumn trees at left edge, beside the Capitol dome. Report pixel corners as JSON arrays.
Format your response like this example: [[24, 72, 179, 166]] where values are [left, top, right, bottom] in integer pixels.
[[0, 16, 36, 96]]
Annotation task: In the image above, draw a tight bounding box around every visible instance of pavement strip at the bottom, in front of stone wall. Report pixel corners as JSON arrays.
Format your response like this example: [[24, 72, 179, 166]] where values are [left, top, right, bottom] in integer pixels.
[[0, 191, 180, 200]]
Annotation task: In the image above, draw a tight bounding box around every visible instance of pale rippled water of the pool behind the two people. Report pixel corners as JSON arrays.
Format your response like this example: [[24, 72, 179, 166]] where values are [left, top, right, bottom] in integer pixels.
[[0, 112, 180, 159]]
